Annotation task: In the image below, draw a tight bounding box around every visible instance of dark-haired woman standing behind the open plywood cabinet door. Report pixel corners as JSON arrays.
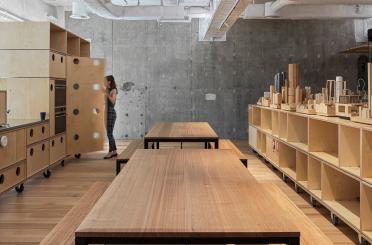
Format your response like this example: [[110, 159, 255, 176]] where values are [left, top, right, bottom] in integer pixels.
[[103, 75, 118, 159]]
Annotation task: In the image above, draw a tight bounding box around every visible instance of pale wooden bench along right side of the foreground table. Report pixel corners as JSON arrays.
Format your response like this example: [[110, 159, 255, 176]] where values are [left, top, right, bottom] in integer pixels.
[[262, 183, 333, 245]]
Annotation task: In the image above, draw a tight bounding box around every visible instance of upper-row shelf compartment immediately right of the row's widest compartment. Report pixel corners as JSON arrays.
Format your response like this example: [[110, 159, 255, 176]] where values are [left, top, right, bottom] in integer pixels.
[[338, 125, 361, 176]]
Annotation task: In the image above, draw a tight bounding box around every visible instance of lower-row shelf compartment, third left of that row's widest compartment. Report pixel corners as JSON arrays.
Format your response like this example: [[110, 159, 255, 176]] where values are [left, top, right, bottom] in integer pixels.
[[279, 143, 296, 180]]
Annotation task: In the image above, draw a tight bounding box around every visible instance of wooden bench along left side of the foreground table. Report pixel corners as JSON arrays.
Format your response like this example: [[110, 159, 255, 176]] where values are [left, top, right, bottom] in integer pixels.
[[40, 182, 107, 245]]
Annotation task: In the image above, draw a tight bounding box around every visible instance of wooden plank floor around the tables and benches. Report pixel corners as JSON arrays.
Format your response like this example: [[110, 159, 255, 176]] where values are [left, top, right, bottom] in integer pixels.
[[0, 141, 358, 245]]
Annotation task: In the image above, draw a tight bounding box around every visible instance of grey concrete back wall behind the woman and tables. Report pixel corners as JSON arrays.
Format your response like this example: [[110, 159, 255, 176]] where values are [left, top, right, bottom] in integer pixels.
[[66, 16, 357, 139]]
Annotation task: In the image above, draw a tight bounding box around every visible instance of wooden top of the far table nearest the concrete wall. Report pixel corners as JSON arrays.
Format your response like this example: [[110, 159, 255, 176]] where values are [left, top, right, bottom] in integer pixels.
[[145, 122, 218, 139]]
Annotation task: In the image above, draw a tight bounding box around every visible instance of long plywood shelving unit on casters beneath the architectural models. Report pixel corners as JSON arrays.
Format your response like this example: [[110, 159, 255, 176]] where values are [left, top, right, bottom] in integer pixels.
[[249, 105, 372, 242]]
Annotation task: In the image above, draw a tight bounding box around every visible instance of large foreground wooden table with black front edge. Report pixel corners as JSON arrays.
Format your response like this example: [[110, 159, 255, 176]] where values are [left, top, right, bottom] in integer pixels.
[[75, 149, 300, 245]]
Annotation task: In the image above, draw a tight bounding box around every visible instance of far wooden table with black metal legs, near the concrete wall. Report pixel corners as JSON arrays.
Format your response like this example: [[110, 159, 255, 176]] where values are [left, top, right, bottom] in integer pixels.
[[144, 122, 218, 149]]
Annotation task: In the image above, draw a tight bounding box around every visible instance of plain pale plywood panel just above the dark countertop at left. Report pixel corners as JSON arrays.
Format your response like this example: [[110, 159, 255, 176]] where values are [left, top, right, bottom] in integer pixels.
[[0, 78, 50, 119]]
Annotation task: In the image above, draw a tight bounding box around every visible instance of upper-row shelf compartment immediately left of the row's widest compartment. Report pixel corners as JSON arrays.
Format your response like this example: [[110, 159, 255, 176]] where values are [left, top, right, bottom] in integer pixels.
[[287, 114, 308, 151]]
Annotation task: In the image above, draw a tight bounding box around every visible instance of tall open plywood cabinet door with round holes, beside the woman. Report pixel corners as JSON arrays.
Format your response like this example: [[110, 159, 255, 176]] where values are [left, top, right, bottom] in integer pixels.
[[66, 57, 105, 155]]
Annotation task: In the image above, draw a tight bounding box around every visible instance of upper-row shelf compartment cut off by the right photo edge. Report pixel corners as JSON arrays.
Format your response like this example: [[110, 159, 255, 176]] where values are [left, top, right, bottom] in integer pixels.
[[361, 130, 372, 183]]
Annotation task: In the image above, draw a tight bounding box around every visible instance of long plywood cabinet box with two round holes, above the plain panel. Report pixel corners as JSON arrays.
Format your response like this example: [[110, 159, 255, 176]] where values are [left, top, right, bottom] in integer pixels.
[[0, 50, 66, 78]]
